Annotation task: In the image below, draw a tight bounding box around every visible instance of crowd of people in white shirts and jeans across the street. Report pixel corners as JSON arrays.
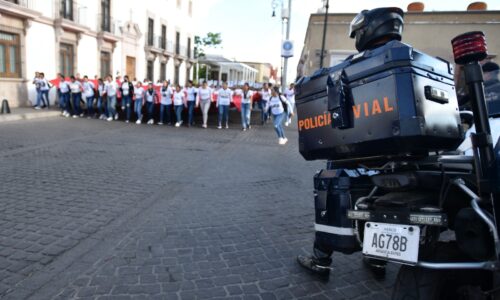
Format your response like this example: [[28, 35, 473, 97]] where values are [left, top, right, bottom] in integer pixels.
[[33, 72, 295, 145]]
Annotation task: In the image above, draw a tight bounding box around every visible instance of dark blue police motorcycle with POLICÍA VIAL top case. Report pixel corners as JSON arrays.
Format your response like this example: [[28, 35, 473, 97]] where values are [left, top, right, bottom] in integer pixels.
[[296, 6, 500, 300]]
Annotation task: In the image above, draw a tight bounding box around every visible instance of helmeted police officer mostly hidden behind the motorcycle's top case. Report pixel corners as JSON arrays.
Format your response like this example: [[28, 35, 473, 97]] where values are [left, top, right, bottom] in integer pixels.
[[297, 7, 403, 276]]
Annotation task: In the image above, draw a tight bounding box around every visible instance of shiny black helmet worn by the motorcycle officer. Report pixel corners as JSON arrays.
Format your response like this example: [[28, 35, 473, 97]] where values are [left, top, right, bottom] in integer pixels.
[[349, 7, 404, 52]]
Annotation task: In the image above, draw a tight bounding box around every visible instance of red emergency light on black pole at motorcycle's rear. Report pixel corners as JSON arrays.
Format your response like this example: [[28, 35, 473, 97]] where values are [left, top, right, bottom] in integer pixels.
[[451, 31, 488, 65]]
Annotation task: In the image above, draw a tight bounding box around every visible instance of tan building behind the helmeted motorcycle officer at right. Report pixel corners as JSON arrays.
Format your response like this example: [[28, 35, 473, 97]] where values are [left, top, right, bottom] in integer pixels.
[[297, 3, 500, 76]]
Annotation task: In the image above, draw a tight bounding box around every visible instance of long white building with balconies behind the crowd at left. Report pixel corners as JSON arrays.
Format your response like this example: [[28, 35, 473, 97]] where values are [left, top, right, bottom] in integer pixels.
[[0, 0, 194, 107]]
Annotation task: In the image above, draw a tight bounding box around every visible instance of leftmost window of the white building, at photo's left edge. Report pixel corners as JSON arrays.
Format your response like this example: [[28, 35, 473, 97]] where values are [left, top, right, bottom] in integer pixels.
[[0, 31, 21, 78]]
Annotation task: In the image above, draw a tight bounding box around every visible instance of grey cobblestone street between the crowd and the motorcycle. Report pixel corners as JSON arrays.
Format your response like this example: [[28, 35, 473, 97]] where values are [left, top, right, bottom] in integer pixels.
[[0, 118, 397, 299]]
